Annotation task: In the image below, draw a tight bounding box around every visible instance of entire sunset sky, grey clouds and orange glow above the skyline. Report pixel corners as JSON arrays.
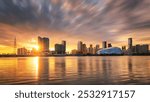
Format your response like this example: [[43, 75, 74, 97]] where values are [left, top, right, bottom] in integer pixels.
[[0, 0, 150, 53]]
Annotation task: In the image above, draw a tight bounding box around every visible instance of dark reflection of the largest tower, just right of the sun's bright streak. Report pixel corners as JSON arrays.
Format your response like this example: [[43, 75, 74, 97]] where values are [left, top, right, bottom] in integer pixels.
[[38, 58, 49, 84]]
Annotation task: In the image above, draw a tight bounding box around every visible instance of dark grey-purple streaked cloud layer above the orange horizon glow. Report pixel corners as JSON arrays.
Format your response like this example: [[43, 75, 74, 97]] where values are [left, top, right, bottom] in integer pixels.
[[0, 0, 150, 39]]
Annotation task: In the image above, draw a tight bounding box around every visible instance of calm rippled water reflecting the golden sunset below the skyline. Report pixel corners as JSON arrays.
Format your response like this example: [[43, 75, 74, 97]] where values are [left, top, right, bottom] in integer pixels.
[[0, 56, 150, 85]]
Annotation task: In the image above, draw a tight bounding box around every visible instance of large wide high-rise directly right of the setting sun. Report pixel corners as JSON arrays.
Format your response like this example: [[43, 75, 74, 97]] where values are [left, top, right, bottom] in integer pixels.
[[38, 36, 49, 52]]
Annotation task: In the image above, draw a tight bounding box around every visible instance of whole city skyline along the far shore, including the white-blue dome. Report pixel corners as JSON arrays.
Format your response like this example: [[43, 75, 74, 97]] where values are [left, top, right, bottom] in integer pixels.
[[12, 36, 150, 55]]
